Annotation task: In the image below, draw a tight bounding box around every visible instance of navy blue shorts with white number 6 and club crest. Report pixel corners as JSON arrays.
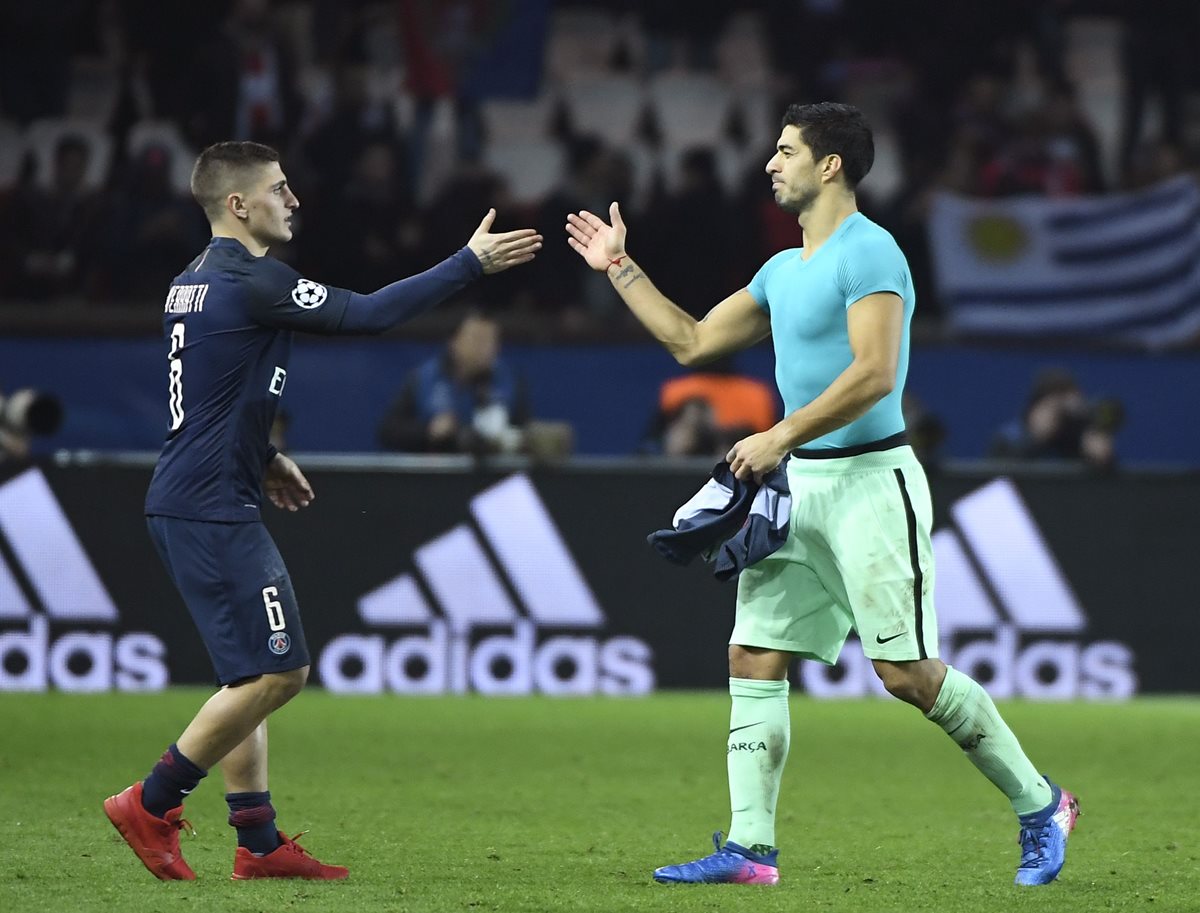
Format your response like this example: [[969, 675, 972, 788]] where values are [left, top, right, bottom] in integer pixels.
[[146, 517, 308, 685]]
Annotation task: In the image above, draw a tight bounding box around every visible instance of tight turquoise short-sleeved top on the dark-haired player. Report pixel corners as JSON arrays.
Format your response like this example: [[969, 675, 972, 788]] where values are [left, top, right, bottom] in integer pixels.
[[748, 212, 917, 449]]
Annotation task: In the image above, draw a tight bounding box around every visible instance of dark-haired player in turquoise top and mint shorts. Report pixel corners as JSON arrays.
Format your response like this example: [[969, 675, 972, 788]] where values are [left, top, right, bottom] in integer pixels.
[[566, 102, 1079, 884]]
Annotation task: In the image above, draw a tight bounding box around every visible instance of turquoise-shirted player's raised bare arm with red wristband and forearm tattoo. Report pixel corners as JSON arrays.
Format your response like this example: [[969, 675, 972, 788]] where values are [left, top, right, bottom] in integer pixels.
[[566, 203, 770, 365]]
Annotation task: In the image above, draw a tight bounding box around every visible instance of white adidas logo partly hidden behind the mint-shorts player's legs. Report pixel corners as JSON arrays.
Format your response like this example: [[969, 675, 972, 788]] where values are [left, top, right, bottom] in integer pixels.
[[800, 477, 1138, 699]]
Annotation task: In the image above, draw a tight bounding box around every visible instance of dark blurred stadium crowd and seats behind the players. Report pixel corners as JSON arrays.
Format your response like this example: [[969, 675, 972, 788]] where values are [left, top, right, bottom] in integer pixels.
[[0, 0, 1200, 340]]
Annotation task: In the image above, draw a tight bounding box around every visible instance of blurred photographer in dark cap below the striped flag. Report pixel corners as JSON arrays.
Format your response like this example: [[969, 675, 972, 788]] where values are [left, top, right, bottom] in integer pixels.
[[990, 368, 1124, 470]]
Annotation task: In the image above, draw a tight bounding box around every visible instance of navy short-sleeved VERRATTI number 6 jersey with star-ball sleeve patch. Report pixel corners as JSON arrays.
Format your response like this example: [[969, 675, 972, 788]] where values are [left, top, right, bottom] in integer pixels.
[[145, 238, 350, 521]]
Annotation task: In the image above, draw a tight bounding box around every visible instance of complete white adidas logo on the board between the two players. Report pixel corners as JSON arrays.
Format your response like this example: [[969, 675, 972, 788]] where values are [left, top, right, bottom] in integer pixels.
[[318, 474, 654, 695]]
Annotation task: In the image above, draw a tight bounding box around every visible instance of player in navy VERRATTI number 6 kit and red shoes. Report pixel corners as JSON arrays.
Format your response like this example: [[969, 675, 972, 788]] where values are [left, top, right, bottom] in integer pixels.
[[104, 143, 541, 881]]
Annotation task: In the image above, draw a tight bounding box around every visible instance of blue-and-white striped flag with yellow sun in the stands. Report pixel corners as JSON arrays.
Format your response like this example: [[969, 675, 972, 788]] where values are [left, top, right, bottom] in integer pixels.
[[929, 176, 1200, 349]]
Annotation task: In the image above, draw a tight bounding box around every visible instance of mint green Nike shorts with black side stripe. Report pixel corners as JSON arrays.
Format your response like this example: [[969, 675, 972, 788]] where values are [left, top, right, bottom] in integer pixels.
[[730, 445, 937, 665]]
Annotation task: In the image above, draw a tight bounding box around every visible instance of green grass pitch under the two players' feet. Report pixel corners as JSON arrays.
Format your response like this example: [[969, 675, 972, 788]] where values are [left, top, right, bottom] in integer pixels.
[[0, 689, 1200, 913]]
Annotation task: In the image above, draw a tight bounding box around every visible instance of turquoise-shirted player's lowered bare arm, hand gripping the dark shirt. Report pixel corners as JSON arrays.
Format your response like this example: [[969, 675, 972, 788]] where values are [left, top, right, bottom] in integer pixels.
[[726, 292, 904, 481]]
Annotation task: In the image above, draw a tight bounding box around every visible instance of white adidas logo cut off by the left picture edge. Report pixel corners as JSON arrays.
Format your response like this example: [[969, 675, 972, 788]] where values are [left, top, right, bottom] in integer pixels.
[[0, 468, 169, 691]]
